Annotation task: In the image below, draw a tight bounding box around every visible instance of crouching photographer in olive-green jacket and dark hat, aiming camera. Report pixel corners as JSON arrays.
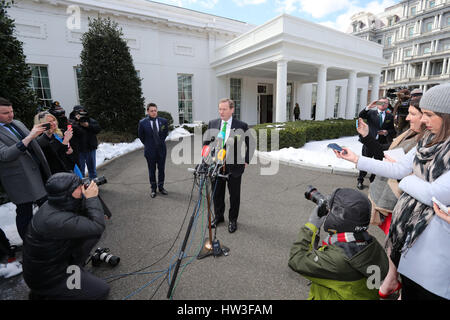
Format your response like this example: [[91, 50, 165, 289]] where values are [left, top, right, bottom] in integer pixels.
[[289, 186, 388, 300]]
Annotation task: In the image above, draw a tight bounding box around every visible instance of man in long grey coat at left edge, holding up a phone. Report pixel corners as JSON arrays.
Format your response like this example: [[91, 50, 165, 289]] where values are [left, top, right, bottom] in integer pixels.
[[0, 98, 51, 239]]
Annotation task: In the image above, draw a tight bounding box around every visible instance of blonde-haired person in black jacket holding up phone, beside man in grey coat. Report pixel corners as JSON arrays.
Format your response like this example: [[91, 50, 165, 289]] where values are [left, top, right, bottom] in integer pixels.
[[34, 111, 82, 178]]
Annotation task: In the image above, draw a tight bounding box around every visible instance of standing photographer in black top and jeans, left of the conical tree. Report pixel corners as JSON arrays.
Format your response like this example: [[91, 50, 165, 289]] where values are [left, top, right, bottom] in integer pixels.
[[69, 105, 101, 179]]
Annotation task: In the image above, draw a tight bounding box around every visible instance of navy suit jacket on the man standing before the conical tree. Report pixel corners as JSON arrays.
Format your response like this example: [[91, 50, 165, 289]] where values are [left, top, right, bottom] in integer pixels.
[[138, 116, 169, 159]]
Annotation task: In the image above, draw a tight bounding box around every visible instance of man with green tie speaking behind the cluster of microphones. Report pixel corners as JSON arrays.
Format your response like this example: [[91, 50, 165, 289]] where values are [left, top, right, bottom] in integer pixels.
[[205, 99, 250, 233]]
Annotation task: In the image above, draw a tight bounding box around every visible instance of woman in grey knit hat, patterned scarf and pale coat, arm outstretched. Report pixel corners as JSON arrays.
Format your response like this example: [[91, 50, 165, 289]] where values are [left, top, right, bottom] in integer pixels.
[[335, 84, 450, 299]]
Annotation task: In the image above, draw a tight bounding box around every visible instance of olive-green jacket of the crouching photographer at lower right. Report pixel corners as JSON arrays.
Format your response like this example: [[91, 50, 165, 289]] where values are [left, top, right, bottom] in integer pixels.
[[289, 223, 389, 300]]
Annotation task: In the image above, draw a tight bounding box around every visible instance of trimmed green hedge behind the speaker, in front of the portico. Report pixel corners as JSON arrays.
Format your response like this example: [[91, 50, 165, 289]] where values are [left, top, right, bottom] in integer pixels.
[[253, 119, 357, 151]]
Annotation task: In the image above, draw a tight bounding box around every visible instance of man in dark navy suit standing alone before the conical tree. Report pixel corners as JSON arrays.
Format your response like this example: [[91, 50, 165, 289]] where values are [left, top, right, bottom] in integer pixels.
[[138, 103, 169, 198]]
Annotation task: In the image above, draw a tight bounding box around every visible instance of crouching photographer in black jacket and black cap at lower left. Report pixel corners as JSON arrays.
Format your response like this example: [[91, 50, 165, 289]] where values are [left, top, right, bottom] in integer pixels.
[[23, 172, 110, 300]]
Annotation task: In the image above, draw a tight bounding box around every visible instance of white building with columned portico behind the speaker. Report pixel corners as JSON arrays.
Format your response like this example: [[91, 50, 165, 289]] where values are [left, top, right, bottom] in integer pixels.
[[8, 0, 386, 125]]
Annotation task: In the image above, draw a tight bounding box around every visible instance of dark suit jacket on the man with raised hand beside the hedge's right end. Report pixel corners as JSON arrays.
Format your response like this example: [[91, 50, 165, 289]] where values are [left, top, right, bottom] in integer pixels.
[[359, 108, 396, 144]]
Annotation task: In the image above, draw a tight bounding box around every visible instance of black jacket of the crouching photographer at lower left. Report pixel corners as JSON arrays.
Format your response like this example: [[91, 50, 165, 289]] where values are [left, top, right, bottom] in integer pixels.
[[23, 197, 105, 290]]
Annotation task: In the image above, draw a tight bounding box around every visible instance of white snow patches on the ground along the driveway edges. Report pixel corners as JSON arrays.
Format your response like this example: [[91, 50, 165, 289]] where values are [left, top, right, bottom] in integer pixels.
[[0, 128, 362, 245]]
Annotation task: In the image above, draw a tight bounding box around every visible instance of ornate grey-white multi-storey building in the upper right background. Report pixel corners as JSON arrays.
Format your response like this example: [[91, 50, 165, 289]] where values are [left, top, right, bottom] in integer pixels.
[[349, 0, 450, 91]]
